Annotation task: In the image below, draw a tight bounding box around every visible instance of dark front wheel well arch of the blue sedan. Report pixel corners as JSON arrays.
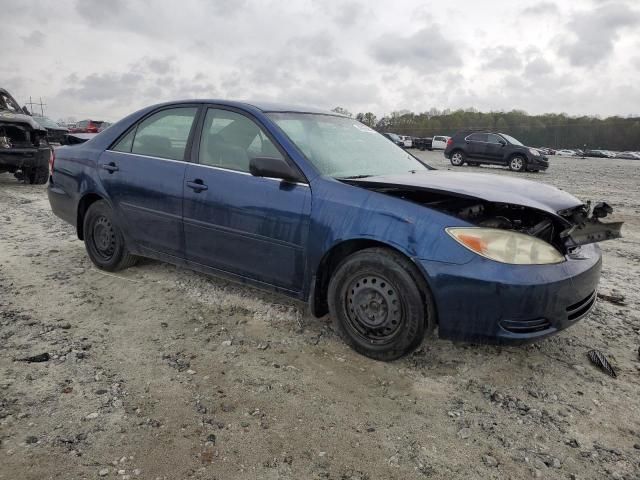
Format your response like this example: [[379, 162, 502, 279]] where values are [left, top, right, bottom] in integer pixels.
[[309, 239, 429, 317]]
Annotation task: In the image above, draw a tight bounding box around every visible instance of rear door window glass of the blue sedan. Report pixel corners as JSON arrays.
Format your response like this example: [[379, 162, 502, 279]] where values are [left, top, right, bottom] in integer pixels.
[[131, 107, 198, 160]]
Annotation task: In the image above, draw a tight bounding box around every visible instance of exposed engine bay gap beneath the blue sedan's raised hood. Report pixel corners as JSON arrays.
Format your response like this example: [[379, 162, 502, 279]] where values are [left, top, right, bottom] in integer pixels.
[[358, 183, 622, 253]]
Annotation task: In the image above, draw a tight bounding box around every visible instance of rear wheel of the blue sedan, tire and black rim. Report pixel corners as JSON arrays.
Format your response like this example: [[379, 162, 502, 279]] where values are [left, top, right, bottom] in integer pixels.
[[82, 200, 137, 272]]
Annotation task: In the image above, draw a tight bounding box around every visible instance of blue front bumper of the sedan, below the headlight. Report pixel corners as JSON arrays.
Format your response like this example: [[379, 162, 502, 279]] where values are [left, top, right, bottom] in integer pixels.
[[420, 244, 602, 344]]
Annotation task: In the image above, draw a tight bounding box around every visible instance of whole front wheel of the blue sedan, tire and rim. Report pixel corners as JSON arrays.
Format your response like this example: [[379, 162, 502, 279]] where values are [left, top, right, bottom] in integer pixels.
[[328, 248, 435, 361]]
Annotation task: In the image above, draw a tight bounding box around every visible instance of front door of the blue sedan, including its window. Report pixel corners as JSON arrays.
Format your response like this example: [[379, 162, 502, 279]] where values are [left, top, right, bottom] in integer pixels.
[[184, 108, 311, 292]]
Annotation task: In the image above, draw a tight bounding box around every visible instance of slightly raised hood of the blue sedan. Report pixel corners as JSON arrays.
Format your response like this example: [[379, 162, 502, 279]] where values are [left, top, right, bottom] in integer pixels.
[[350, 170, 583, 215]]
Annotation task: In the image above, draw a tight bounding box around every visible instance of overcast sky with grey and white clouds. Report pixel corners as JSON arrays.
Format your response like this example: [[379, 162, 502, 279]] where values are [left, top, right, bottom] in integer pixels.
[[0, 0, 640, 120]]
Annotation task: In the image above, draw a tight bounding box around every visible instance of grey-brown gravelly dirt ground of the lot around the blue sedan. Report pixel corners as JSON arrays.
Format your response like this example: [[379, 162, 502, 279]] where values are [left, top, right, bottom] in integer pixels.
[[0, 152, 640, 480]]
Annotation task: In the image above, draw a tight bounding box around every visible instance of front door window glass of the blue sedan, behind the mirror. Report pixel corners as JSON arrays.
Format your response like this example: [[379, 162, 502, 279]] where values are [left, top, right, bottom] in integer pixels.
[[199, 108, 282, 172]]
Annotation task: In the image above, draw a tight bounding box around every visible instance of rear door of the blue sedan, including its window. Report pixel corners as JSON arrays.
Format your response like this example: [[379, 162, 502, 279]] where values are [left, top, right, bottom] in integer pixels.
[[98, 105, 199, 258]]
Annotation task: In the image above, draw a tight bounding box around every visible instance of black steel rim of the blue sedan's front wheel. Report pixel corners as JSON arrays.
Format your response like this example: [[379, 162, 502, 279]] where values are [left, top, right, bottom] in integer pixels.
[[346, 275, 402, 343]]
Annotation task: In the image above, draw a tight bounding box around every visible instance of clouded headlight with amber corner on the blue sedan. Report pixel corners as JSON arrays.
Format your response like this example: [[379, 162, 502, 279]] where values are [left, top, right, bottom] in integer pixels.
[[446, 227, 564, 265]]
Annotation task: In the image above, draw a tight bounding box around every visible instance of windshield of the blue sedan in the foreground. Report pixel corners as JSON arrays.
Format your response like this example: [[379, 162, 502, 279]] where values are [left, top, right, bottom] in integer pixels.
[[269, 113, 428, 178]]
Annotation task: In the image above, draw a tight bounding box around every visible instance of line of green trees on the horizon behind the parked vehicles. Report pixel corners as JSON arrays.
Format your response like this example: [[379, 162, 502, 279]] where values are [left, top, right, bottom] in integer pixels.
[[333, 107, 640, 151]]
